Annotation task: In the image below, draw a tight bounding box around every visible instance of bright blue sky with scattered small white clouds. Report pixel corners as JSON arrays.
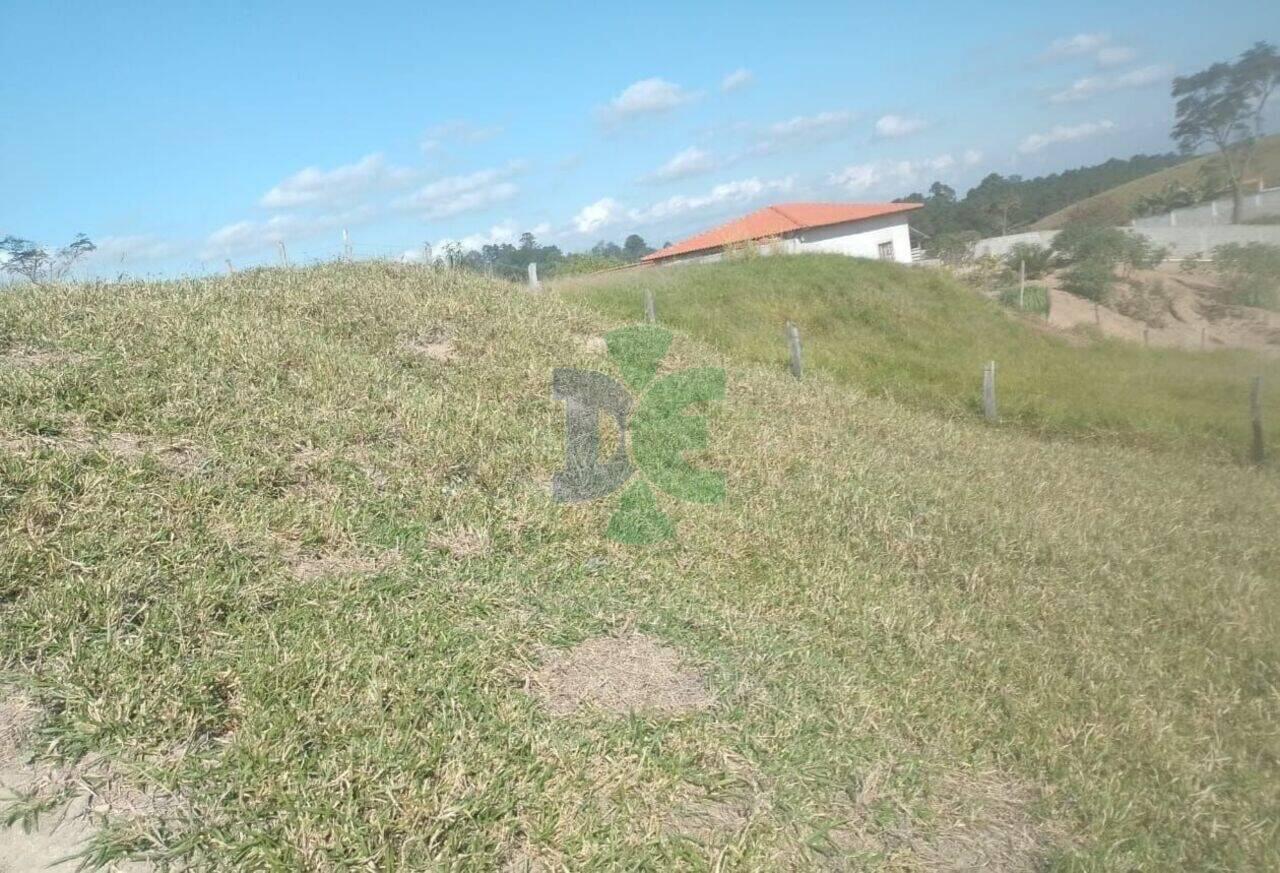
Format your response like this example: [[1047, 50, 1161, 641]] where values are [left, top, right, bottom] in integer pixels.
[[0, 0, 1280, 274]]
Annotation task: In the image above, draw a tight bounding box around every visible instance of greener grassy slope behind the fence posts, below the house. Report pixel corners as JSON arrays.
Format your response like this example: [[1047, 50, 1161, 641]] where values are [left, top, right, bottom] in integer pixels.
[[566, 256, 1280, 456]]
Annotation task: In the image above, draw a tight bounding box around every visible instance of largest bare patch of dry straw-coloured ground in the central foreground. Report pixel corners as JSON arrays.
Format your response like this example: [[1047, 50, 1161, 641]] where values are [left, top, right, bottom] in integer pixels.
[[527, 634, 713, 716]]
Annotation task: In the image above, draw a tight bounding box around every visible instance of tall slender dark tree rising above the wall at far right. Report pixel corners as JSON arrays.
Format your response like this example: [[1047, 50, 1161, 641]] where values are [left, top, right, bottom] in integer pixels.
[[1172, 42, 1280, 224]]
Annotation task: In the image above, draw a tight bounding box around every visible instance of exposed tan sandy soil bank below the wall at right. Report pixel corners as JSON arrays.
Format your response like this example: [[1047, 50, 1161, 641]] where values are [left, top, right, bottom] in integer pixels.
[[1036, 265, 1280, 356]]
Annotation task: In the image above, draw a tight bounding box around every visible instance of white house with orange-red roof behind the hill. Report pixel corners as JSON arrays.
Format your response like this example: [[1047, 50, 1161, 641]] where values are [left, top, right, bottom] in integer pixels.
[[644, 204, 920, 264]]
